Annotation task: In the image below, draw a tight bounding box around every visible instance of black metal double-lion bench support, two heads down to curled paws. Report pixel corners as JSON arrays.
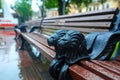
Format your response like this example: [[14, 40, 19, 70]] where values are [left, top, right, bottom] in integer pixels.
[[48, 30, 89, 80]]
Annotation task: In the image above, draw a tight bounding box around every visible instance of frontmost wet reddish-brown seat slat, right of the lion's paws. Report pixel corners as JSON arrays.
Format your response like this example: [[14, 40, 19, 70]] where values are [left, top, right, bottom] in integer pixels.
[[69, 64, 104, 80]]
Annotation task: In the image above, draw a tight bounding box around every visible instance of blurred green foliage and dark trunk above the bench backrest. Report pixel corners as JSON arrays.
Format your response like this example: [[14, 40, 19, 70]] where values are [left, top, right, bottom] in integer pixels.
[[45, 0, 107, 15]]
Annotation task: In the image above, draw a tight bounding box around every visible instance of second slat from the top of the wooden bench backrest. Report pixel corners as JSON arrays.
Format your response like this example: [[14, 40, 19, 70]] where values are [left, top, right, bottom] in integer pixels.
[[43, 14, 114, 24]]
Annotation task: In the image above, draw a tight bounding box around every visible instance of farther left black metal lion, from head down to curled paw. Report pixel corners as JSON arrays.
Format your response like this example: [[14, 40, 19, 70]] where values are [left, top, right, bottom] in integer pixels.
[[47, 30, 67, 80]]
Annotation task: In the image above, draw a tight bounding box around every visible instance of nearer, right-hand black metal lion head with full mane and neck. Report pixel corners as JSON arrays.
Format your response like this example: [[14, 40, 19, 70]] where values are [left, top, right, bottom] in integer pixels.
[[58, 30, 88, 64]]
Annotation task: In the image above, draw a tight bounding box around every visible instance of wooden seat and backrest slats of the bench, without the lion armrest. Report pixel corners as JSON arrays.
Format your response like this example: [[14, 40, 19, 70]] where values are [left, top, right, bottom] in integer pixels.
[[16, 8, 120, 80]]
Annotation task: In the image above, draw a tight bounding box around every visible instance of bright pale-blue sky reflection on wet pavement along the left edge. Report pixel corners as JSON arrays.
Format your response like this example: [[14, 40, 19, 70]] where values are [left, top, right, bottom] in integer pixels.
[[0, 30, 22, 80]]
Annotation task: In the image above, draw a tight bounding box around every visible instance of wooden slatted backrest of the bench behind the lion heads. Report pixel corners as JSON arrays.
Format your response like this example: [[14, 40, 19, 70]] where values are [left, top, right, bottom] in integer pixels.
[[25, 8, 119, 35]]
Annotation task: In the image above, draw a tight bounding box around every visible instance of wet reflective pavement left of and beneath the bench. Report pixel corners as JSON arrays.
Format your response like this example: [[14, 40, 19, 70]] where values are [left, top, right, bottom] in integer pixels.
[[0, 31, 53, 80]]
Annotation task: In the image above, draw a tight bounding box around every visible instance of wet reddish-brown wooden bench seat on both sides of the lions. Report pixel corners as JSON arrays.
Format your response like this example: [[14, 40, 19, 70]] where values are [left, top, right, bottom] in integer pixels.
[[16, 29, 120, 80]]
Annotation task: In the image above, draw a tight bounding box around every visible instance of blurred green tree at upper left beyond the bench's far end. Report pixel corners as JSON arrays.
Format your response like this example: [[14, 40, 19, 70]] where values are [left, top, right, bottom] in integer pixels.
[[14, 0, 32, 21]]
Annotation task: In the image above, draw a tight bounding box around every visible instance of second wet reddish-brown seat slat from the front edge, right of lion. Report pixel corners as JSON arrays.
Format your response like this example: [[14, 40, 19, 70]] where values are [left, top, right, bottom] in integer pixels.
[[81, 61, 120, 80]]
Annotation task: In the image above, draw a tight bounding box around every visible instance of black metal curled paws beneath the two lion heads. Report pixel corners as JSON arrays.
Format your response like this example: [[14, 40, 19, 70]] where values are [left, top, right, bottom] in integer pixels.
[[49, 58, 73, 80]]
